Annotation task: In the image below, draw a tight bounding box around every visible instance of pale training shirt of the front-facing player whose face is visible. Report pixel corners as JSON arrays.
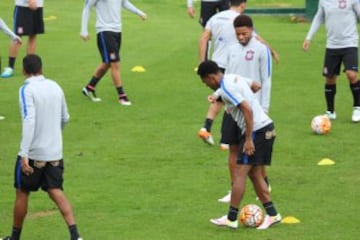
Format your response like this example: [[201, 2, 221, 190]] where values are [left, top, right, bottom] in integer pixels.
[[225, 36, 272, 113]]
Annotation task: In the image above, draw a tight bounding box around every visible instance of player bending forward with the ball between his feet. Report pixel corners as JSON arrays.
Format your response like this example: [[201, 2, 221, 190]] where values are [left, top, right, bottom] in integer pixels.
[[198, 61, 281, 230]]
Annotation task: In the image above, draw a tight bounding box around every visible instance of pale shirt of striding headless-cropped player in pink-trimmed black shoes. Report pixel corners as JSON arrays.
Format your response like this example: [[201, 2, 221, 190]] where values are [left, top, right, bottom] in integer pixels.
[[81, 0, 145, 36]]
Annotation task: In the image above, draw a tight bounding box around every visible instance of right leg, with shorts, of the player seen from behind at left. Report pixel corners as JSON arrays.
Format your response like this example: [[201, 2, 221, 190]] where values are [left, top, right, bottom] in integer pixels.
[[42, 160, 80, 240]]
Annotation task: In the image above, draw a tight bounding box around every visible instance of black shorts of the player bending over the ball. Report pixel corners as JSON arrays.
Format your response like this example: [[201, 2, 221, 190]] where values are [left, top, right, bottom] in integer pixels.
[[237, 123, 275, 166]]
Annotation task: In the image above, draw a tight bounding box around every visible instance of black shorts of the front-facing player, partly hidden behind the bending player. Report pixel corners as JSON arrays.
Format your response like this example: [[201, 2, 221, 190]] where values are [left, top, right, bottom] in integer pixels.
[[220, 111, 241, 145]]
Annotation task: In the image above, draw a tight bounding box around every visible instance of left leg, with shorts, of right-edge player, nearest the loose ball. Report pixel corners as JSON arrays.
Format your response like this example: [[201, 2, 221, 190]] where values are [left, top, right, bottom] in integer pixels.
[[323, 49, 342, 120]]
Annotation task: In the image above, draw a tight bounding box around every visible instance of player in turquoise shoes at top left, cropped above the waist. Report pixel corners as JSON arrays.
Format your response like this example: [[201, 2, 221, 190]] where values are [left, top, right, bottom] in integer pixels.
[[1, 0, 45, 78]]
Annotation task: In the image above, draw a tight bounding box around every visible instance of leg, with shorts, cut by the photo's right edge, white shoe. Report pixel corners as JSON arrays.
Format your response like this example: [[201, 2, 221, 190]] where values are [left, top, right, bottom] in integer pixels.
[[343, 48, 360, 122]]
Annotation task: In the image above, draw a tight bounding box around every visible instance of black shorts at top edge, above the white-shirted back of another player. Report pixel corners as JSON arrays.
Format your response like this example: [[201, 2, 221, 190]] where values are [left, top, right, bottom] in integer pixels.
[[199, 0, 230, 27]]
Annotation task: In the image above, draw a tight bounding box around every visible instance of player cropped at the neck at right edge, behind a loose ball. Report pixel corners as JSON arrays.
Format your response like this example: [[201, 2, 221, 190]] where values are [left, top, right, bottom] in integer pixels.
[[302, 0, 360, 122]]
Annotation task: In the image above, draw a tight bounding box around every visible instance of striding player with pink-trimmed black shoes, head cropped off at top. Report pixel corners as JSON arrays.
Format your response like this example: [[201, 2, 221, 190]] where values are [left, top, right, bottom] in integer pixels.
[[80, 0, 147, 106]]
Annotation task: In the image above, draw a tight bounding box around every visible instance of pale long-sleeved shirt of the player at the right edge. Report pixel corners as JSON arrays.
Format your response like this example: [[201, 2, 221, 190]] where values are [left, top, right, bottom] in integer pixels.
[[306, 0, 360, 49]]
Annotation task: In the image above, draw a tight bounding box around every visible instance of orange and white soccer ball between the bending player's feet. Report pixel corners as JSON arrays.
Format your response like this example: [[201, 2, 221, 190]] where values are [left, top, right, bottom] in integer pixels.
[[239, 204, 264, 227]]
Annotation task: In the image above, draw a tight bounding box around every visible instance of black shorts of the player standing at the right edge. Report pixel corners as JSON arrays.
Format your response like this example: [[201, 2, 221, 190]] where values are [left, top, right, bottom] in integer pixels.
[[323, 47, 359, 77]]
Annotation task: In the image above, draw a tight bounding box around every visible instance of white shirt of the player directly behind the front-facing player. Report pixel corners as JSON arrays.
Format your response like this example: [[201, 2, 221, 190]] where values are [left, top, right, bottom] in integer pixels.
[[205, 9, 240, 68]]
